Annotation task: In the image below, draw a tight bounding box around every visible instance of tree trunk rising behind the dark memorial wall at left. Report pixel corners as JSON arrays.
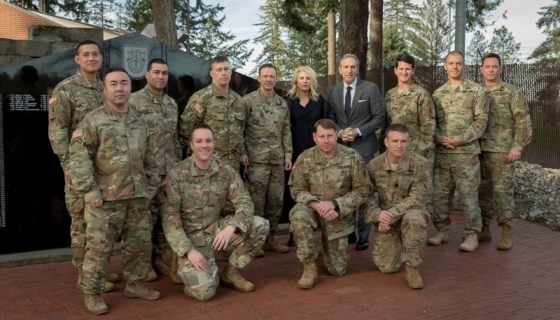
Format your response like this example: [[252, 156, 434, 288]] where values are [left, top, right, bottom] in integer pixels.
[[152, 0, 179, 48]]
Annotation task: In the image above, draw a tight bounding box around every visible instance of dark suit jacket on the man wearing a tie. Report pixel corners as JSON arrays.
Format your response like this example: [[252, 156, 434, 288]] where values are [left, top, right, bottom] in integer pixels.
[[327, 79, 385, 163]]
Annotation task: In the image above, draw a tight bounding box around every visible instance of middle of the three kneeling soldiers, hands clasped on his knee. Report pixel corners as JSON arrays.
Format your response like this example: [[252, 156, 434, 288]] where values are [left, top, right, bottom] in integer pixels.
[[288, 119, 370, 289]]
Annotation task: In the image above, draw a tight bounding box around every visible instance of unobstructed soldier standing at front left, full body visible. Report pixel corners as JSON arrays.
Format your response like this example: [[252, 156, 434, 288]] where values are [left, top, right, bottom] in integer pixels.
[[70, 69, 162, 314]]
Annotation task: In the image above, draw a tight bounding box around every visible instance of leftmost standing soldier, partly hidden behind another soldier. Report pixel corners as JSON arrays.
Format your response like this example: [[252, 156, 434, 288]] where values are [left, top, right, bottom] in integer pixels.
[[49, 40, 118, 292]]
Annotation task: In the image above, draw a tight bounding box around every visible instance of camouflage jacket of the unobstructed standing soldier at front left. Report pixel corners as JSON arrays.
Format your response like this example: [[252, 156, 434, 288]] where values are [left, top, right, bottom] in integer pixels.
[[70, 104, 161, 202]]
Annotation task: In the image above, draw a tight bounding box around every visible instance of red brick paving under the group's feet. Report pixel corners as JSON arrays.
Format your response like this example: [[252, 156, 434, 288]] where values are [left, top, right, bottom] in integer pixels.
[[0, 211, 560, 320]]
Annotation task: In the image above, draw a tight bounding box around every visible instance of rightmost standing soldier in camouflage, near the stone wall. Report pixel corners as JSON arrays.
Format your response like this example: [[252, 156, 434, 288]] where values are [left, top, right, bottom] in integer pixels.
[[478, 53, 533, 250]]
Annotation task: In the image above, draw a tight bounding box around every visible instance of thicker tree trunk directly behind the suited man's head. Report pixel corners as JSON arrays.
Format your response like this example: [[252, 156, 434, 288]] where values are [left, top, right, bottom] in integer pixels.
[[339, 0, 369, 76]]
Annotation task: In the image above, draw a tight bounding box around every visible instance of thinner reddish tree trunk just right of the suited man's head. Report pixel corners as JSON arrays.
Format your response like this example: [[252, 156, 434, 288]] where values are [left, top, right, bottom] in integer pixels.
[[367, 0, 383, 87]]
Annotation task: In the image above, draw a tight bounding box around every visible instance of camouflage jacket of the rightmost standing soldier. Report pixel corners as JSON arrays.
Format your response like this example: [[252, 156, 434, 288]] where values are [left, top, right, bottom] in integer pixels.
[[481, 83, 533, 153]]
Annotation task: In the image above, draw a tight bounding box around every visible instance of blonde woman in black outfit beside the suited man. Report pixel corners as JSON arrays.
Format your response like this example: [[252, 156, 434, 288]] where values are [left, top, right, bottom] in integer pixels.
[[283, 66, 326, 246]]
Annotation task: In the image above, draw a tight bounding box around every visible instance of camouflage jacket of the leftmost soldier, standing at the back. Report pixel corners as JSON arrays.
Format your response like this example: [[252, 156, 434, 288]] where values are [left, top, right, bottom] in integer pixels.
[[49, 70, 105, 171]]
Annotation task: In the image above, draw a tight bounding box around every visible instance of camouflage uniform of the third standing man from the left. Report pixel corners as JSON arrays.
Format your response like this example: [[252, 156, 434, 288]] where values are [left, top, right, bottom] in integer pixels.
[[129, 86, 181, 255]]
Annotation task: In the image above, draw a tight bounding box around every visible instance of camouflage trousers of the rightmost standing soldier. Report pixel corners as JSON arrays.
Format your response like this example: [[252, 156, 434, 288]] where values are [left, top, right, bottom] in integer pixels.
[[478, 152, 514, 226]]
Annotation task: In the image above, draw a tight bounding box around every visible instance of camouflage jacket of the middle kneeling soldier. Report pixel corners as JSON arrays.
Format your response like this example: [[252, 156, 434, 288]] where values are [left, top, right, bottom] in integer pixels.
[[288, 144, 370, 239]]
